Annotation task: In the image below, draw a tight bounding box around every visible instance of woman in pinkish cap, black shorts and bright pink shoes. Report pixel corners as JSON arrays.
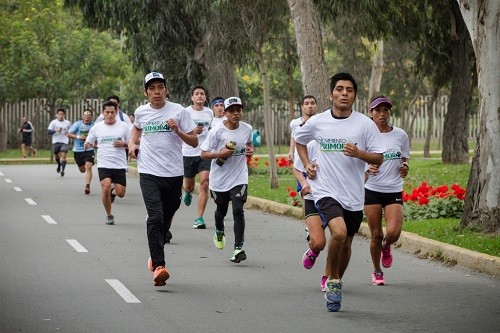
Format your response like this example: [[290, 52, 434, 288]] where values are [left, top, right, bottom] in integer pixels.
[[364, 96, 410, 285]]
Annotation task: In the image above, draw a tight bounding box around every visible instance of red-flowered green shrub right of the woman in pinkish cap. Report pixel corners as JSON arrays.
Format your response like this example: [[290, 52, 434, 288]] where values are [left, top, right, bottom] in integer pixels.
[[403, 182, 465, 220]]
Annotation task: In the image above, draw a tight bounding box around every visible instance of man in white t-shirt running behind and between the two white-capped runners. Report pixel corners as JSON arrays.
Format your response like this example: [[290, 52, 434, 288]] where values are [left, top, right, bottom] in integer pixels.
[[182, 85, 214, 229]]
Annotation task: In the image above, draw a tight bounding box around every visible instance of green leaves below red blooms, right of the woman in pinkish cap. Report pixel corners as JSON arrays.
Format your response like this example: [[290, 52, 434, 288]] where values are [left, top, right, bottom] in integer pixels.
[[403, 197, 464, 220]]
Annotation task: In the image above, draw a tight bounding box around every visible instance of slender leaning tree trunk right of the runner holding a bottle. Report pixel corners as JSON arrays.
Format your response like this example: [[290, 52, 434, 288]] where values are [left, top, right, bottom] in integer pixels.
[[255, 45, 279, 188]]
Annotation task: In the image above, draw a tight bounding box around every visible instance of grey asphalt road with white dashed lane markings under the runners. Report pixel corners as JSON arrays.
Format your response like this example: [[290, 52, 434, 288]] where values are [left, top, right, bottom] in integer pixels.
[[0, 165, 500, 333]]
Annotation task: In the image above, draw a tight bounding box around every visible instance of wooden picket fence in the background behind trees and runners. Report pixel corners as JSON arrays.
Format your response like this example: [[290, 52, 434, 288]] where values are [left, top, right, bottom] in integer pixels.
[[0, 95, 479, 149]]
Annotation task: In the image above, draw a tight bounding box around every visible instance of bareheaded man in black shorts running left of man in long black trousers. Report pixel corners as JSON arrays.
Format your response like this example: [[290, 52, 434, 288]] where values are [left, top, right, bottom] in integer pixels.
[[84, 101, 130, 225]]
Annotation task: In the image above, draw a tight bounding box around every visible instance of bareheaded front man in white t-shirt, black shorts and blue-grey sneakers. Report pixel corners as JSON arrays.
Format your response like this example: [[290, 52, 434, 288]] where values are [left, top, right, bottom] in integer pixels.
[[294, 73, 386, 312]]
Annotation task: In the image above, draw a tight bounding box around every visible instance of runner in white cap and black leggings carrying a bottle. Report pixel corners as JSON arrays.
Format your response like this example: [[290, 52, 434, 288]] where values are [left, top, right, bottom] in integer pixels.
[[201, 97, 253, 263]]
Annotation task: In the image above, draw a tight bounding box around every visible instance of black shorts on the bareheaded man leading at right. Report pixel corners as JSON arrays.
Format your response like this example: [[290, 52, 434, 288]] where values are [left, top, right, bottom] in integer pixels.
[[316, 197, 363, 237]]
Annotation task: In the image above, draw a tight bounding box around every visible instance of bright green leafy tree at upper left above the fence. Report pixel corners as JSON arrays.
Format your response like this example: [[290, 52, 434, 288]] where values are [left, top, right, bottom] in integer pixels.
[[0, 0, 129, 149]]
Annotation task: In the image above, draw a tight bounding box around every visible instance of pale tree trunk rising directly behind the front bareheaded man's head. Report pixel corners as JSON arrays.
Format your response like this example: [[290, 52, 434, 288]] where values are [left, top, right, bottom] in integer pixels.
[[288, 0, 331, 112]]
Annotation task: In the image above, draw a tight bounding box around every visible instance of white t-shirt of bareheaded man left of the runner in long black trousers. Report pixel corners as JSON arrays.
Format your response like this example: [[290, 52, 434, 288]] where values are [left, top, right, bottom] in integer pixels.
[[85, 120, 130, 169]]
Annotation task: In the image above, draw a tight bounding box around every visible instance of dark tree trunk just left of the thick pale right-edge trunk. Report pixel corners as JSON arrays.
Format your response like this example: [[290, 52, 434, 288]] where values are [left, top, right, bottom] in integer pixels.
[[441, 2, 472, 164]]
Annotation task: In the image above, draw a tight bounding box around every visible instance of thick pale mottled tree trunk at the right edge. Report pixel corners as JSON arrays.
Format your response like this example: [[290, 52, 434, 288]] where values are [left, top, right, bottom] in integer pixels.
[[457, 0, 500, 234]]
